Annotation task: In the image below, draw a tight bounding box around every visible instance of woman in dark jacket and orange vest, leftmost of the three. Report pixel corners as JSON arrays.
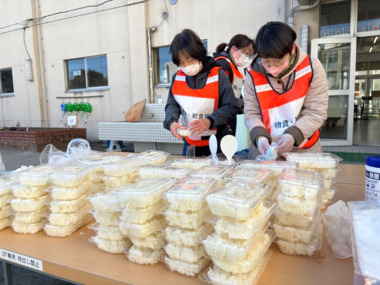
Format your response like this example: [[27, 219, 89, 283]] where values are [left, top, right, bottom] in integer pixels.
[[164, 29, 239, 156]]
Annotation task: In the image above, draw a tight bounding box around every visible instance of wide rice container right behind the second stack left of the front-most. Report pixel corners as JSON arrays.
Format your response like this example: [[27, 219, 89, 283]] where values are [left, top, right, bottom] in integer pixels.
[[139, 165, 194, 179]]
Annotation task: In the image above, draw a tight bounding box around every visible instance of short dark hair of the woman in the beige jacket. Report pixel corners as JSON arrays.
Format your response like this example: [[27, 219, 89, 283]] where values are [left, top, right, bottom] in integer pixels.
[[256, 22, 297, 58]]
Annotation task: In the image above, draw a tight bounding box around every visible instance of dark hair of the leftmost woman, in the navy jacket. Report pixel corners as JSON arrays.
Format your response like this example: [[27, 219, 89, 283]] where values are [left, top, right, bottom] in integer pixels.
[[170, 29, 207, 66]]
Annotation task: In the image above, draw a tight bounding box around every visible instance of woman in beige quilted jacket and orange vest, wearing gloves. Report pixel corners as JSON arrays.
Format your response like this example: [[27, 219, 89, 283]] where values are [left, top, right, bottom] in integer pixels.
[[244, 22, 329, 158]]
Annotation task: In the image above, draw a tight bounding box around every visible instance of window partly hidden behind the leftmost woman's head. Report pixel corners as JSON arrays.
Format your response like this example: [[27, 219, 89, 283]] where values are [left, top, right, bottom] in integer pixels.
[[153, 41, 207, 85]]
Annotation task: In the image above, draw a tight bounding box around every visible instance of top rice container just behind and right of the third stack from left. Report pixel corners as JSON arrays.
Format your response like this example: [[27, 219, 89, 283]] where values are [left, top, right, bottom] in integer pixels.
[[102, 159, 149, 177]]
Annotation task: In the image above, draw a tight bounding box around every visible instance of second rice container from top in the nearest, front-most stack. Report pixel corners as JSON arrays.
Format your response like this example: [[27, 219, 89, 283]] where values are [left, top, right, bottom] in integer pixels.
[[208, 201, 277, 239]]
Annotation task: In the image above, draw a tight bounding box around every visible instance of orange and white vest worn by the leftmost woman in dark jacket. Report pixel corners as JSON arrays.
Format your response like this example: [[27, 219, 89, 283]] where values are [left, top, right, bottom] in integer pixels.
[[172, 67, 220, 147]]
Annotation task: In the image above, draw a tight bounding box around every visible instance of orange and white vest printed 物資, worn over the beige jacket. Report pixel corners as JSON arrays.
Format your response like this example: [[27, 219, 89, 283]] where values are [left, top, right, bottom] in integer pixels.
[[248, 56, 320, 148]]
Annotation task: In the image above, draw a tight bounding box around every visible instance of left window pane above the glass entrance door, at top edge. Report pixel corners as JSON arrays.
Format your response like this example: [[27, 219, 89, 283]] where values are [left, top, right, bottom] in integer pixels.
[[320, 0, 351, 37]]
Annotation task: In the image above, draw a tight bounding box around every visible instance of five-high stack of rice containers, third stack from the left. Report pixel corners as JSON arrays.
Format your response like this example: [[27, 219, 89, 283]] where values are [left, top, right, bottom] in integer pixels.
[[44, 165, 93, 237]]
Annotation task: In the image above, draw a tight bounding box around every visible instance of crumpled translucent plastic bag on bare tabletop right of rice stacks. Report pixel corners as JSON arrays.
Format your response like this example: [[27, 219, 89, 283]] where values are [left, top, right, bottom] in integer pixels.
[[322, 200, 352, 258]]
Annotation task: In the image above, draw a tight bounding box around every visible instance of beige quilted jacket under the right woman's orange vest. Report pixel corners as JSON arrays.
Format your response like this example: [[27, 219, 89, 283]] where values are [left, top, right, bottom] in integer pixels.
[[244, 47, 329, 157]]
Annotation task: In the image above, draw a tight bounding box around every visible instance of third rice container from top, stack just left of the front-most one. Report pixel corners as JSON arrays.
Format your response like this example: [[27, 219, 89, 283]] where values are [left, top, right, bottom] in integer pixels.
[[165, 222, 214, 246]]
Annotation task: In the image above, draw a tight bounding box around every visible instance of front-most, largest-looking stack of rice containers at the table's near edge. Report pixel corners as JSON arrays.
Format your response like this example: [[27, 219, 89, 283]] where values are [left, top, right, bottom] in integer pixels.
[[201, 178, 276, 284]]
